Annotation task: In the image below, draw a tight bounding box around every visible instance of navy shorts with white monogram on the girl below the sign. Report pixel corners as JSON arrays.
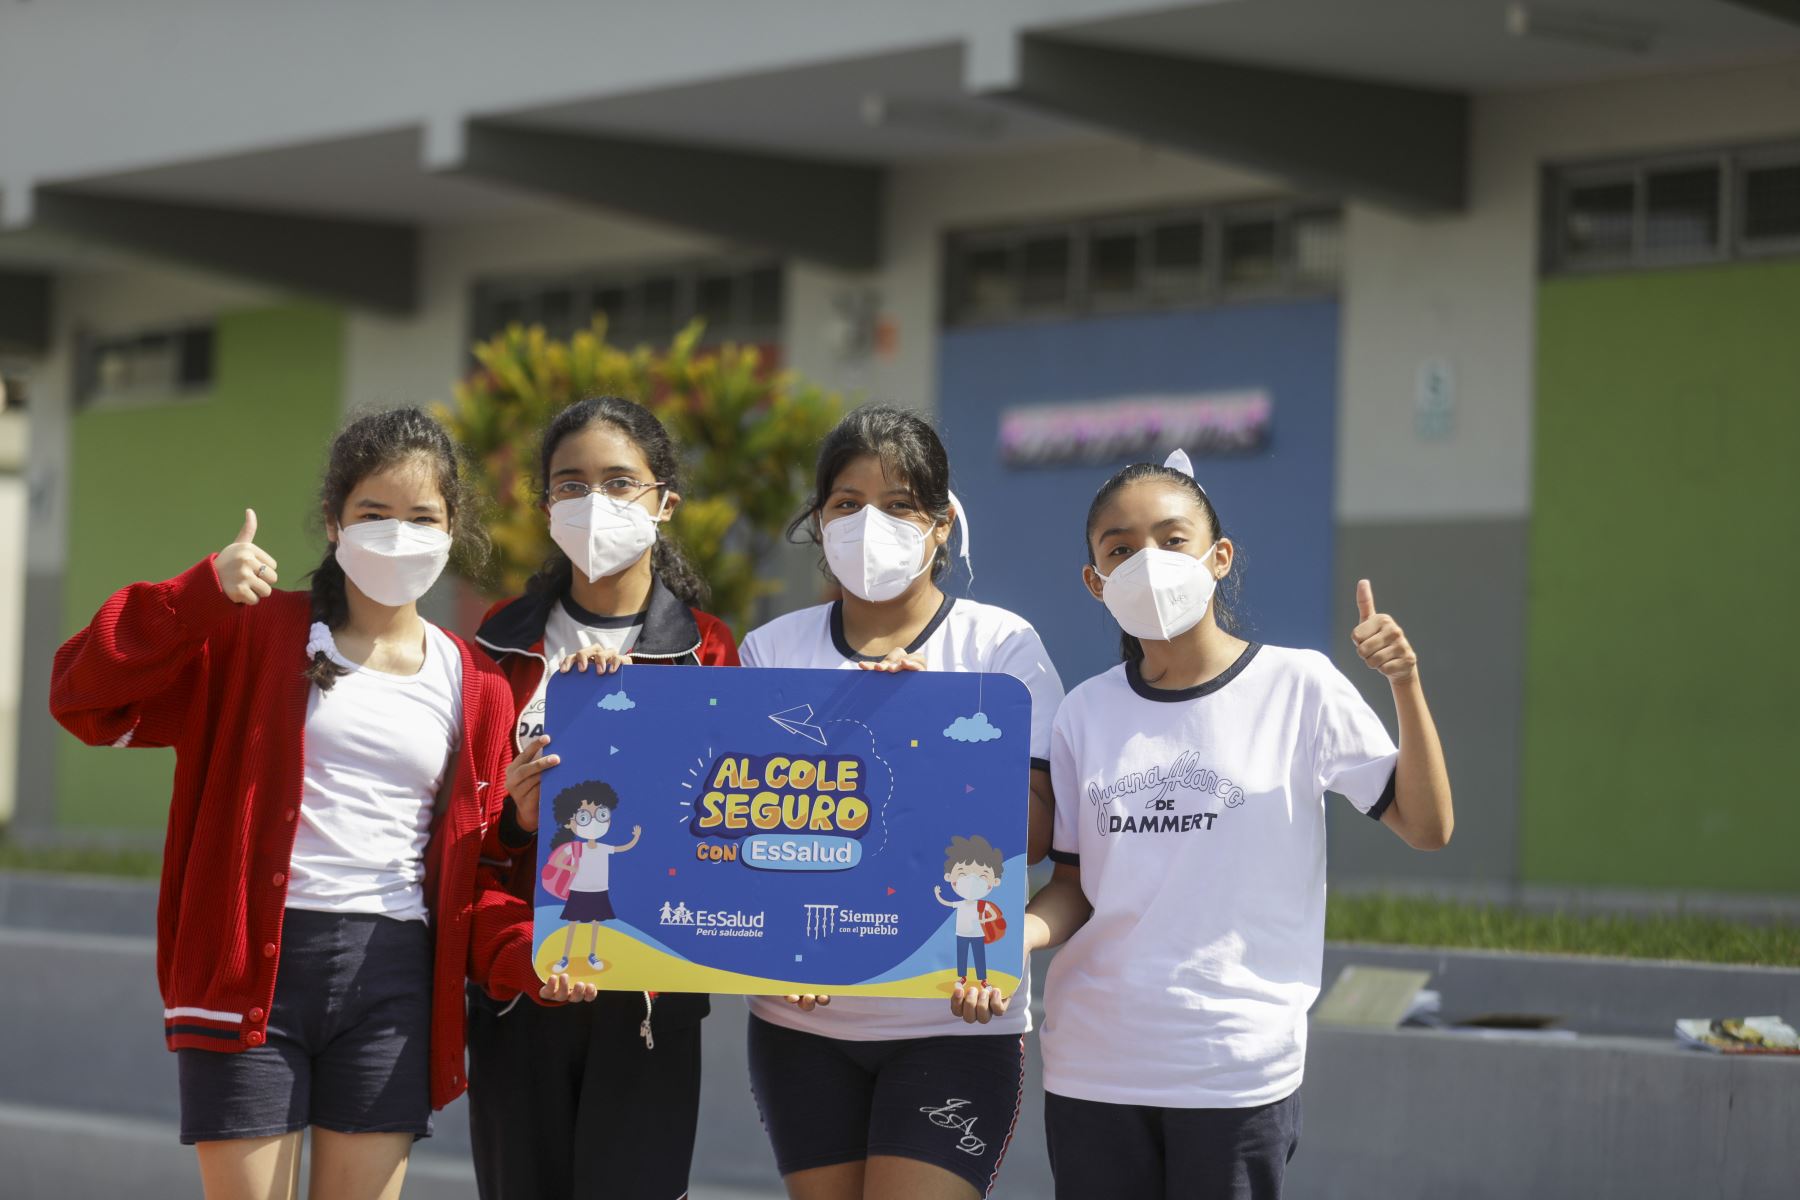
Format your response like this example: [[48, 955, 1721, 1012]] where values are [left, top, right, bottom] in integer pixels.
[[751, 1015, 1024, 1196]]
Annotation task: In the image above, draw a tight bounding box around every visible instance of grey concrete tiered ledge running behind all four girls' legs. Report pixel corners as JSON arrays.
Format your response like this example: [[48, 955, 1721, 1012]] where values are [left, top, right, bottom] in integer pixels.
[[0, 873, 1800, 1200]]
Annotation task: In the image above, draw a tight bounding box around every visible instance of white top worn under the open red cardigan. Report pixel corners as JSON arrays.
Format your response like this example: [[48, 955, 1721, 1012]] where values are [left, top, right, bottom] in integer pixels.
[[288, 622, 463, 921]]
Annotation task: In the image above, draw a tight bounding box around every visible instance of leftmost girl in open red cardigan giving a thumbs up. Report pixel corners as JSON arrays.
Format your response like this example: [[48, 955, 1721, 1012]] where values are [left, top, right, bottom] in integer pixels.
[[50, 408, 594, 1200]]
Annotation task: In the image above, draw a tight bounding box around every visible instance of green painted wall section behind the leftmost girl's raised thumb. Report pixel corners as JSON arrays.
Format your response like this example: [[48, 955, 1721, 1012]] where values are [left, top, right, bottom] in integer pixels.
[[56, 306, 344, 831]]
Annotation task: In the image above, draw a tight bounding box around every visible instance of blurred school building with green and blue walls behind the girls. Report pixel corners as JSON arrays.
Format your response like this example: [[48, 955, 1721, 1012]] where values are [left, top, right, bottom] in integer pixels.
[[0, 0, 1800, 903]]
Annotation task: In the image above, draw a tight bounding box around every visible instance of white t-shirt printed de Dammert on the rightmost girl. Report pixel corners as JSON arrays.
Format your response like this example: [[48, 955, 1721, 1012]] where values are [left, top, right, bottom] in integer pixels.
[[1040, 646, 1399, 1108]]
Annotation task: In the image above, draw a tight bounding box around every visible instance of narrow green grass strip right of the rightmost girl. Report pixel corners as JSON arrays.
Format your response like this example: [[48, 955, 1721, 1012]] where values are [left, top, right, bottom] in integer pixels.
[[1325, 894, 1800, 966]]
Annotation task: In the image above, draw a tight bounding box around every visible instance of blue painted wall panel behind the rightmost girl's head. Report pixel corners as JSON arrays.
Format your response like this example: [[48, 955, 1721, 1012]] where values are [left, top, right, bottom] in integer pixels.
[[938, 299, 1337, 687]]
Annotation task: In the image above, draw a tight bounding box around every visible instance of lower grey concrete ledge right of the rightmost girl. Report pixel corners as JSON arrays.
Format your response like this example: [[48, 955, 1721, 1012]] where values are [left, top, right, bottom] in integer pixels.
[[1289, 1027, 1800, 1200]]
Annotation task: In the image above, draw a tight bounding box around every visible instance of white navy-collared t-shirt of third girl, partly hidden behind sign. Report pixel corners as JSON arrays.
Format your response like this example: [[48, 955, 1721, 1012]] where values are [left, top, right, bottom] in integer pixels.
[[738, 596, 1062, 1042]]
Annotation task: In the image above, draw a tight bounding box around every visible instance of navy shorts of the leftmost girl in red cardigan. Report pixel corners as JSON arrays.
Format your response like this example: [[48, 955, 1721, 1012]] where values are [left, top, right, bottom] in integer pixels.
[[175, 909, 432, 1146]]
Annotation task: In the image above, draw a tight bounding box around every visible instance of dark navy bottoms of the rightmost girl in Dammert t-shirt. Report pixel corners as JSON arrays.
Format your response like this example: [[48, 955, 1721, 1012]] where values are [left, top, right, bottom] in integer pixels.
[[1044, 1092, 1300, 1200]]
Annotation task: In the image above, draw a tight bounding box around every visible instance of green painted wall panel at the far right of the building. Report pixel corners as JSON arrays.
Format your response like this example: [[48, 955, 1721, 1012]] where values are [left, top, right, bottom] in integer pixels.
[[1526, 263, 1800, 892]]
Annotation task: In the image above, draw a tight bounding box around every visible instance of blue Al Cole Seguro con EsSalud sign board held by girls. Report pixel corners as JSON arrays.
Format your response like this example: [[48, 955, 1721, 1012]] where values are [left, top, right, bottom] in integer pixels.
[[533, 666, 1031, 999]]
